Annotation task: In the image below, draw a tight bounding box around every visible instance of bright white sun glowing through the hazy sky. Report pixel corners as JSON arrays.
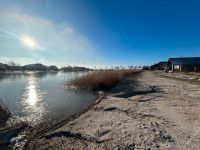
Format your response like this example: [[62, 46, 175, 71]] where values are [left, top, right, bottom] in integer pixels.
[[21, 35, 37, 49]]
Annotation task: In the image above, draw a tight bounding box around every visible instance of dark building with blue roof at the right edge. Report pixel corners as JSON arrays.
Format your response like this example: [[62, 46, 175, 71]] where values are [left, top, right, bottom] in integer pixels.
[[168, 57, 200, 72]]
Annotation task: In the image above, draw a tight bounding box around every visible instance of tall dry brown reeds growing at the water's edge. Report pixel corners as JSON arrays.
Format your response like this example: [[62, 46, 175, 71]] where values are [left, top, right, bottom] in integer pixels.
[[68, 70, 138, 91]]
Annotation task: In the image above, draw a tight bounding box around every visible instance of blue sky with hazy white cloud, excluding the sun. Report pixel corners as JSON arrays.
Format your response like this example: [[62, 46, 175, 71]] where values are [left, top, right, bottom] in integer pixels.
[[0, 0, 200, 67]]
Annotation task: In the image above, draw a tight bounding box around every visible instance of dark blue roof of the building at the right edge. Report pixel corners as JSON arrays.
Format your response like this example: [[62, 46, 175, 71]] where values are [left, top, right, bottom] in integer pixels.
[[169, 57, 200, 65]]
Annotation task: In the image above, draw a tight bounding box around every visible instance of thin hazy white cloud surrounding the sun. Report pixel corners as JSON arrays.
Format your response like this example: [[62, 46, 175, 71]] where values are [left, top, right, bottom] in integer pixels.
[[0, 12, 98, 64]]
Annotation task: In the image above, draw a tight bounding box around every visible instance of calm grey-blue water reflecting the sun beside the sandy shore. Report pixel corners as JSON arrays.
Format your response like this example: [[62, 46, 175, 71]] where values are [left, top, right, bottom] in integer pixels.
[[0, 72, 95, 123]]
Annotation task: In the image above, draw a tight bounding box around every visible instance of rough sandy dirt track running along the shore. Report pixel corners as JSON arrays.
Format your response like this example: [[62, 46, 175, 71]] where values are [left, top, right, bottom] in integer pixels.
[[28, 72, 200, 149]]
